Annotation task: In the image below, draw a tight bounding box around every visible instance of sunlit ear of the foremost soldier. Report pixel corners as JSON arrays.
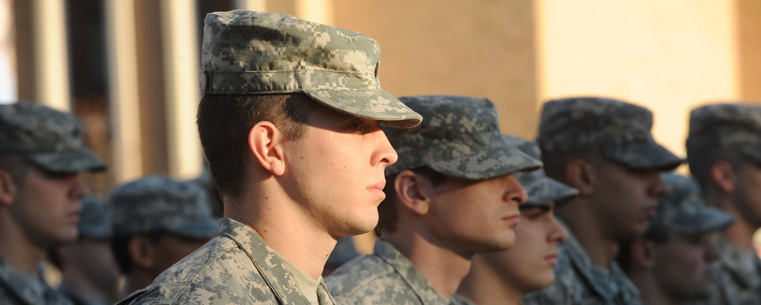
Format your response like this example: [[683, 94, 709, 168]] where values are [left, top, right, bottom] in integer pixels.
[[248, 121, 285, 176]]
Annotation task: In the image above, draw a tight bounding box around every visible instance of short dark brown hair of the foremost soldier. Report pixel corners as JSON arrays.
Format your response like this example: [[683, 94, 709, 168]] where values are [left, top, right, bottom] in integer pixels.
[[196, 93, 316, 197]]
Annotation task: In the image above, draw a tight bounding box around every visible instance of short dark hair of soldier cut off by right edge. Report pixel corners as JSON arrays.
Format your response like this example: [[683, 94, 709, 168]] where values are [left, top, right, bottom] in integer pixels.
[[687, 148, 749, 190]]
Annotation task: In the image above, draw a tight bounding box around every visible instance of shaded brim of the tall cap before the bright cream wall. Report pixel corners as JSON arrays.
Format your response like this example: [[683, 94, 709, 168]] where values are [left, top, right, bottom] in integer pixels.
[[602, 142, 684, 171]]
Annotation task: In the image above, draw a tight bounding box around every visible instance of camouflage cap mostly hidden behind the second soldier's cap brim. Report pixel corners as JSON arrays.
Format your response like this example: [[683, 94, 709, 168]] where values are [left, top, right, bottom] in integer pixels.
[[504, 135, 579, 206]]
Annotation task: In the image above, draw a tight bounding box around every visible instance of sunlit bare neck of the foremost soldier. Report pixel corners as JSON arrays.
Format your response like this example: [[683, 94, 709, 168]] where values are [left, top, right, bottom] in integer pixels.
[[224, 182, 337, 280]]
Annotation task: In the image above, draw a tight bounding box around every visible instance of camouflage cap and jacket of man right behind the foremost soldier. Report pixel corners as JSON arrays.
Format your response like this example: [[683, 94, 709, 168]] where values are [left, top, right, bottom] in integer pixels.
[[326, 96, 541, 304]]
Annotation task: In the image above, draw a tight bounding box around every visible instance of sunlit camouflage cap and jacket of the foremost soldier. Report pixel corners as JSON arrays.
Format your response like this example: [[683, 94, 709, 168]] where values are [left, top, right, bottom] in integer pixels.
[[121, 10, 422, 304]]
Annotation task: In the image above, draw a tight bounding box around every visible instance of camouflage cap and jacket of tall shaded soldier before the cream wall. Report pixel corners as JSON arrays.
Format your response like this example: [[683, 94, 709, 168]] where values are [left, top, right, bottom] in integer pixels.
[[523, 97, 683, 305]]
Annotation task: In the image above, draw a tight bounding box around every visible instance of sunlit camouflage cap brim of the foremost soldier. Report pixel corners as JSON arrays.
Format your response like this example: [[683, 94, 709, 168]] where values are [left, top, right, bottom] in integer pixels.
[[304, 89, 423, 128]]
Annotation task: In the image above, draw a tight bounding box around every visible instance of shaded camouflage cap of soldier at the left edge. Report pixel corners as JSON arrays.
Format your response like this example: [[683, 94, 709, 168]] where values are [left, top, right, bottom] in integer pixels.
[[0, 103, 107, 173]]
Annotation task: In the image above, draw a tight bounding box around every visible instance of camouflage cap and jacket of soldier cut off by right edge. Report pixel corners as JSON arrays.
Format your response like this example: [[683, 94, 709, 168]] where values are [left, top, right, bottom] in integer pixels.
[[687, 104, 761, 305]]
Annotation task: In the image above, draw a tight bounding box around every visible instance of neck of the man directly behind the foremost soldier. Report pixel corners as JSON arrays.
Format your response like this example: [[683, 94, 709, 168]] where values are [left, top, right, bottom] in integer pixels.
[[383, 226, 470, 298]]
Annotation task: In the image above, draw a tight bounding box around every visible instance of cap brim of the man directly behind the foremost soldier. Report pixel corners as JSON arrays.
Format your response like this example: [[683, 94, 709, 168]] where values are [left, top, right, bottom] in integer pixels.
[[426, 143, 542, 180]]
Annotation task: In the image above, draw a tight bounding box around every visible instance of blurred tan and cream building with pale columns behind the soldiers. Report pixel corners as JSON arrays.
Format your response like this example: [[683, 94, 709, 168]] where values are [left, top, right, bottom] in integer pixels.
[[0, 0, 761, 251]]
